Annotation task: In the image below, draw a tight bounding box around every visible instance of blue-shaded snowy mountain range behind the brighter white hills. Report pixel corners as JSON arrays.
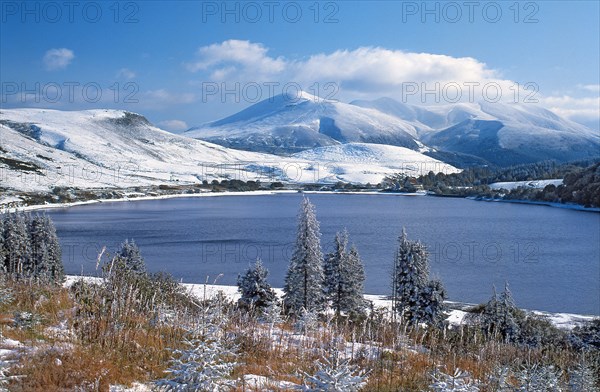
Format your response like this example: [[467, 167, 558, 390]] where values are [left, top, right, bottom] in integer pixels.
[[185, 93, 600, 166]]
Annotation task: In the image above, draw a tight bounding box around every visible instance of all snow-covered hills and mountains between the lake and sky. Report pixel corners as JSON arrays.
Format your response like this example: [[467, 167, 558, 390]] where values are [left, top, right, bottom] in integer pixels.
[[0, 93, 600, 191]]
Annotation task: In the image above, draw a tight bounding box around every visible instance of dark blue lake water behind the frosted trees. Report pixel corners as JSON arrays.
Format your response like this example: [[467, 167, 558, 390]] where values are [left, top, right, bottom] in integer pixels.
[[48, 194, 600, 315]]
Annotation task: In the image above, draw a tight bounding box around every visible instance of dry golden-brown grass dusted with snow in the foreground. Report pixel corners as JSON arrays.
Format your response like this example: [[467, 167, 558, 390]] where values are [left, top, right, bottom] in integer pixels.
[[0, 282, 596, 392]]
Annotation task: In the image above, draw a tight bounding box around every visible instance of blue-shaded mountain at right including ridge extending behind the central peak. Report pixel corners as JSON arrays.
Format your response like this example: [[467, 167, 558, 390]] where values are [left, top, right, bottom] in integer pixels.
[[353, 98, 600, 166]]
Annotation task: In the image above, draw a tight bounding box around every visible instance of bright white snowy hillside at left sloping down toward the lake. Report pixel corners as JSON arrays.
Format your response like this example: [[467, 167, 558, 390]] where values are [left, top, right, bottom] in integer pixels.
[[0, 109, 290, 190]]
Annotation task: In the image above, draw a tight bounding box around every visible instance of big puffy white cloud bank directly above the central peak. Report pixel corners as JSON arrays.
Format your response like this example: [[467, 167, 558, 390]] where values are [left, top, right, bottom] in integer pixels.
[[186, 40, 514, 103]]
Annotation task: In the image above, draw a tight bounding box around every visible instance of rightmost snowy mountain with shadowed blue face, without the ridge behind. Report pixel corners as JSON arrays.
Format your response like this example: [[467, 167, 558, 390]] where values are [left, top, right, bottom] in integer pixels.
[[422, 103, 600, 166]]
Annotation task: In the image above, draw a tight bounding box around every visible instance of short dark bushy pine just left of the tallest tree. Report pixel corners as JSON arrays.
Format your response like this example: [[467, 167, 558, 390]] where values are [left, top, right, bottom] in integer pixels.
[[237, 259, 277, 310]]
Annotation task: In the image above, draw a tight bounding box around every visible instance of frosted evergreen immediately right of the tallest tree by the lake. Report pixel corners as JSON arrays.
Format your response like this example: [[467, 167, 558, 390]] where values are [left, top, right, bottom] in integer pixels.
[[323, 230, 365, 315]]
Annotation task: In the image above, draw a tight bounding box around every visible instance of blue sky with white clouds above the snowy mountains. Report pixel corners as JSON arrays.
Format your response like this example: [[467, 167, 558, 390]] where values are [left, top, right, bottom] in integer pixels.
[[0, 0, 600, 132]]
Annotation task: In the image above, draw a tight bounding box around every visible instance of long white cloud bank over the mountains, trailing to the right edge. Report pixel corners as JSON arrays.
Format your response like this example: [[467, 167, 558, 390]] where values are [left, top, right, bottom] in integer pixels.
[[185, 40, 599, 124]]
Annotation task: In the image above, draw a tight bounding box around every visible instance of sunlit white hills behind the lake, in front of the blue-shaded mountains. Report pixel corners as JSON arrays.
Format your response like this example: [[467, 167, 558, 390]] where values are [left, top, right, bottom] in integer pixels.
[[0, 109, 456, 191]]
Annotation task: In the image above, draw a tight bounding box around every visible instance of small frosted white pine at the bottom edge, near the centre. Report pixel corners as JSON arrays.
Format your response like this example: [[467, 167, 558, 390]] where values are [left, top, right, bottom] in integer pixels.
[[303, 349, 368, 392]]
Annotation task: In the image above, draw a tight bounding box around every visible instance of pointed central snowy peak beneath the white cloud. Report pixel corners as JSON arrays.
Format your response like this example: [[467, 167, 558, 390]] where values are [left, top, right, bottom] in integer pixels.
[[185, 92, 420, 154]]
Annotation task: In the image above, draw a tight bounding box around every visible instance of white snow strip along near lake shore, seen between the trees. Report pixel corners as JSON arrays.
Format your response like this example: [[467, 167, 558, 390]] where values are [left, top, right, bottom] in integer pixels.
[[65, 275, 598, 330]]
